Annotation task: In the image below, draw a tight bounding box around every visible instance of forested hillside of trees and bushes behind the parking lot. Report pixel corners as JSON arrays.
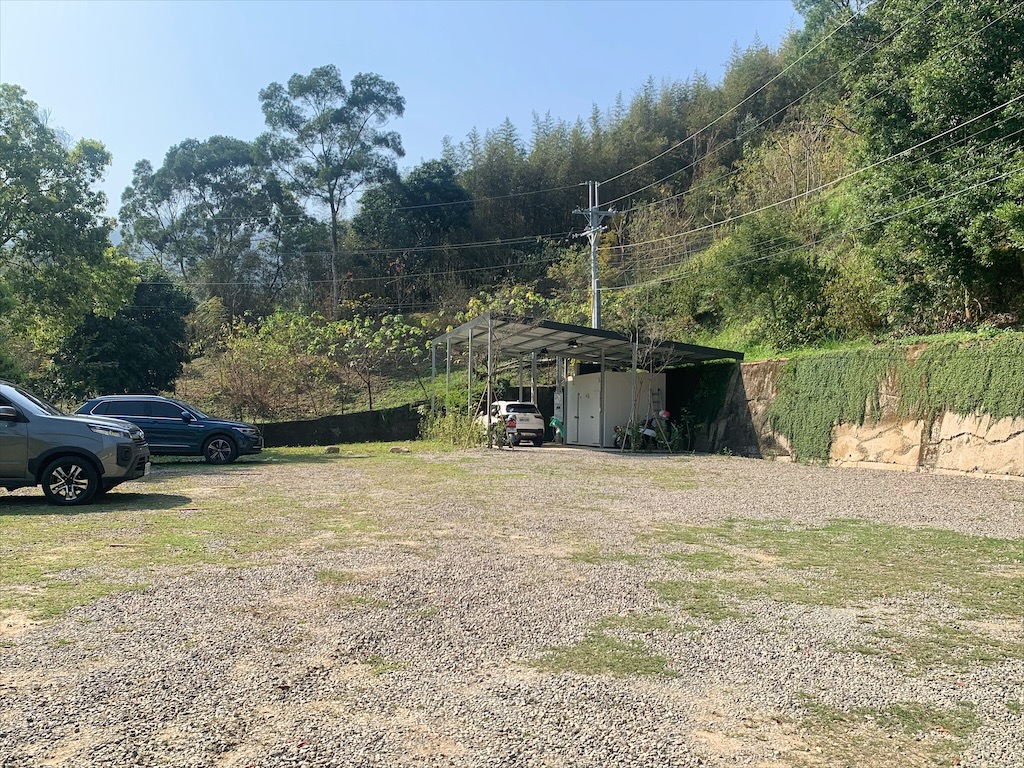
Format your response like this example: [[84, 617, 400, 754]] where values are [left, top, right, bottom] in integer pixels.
[[0, 0, 1024, 418]]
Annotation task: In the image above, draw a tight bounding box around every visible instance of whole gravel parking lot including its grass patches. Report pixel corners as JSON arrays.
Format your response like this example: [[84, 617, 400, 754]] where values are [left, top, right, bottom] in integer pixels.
[[0, 444, 1024, 768]]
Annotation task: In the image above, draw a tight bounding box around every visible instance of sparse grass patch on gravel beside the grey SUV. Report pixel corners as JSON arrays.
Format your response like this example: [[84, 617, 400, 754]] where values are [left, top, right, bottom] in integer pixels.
[[0, 446, 385, 618]]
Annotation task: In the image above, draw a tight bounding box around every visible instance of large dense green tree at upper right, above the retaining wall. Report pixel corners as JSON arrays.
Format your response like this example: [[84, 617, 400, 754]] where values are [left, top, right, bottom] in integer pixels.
[[850, 0, 1024, 332]]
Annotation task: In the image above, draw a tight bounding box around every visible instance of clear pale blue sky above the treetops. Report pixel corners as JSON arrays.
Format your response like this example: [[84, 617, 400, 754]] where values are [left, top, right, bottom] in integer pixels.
[[0, 0, 802, 213]]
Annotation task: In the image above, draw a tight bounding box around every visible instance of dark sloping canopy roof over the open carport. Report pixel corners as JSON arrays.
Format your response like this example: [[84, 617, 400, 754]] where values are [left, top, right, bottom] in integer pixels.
[[433, 314, 743, 368]]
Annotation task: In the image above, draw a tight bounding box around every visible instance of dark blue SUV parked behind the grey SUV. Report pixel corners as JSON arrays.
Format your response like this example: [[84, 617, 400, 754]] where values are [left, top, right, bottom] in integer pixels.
[[76, 394, 263, 464]]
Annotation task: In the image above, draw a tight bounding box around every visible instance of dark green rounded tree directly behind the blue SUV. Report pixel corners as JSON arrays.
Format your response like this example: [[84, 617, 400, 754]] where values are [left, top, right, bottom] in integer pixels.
[[48, 265, 195, 399]]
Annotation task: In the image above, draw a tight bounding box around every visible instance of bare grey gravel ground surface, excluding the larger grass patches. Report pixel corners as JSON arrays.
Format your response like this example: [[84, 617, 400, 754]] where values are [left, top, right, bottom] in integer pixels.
[[0, 446, 1024, 768]]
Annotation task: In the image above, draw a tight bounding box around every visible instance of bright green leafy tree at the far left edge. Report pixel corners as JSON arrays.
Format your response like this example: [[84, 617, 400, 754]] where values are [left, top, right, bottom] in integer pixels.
[[0, 84, 134, 349]]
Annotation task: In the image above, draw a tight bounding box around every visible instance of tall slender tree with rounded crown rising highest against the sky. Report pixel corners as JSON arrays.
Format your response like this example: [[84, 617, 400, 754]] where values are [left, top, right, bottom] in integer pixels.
[[259, 65, 406, 316]]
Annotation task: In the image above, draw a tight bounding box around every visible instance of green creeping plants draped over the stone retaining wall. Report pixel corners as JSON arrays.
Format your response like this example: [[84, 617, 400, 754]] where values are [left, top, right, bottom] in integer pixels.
[[768, 332, 1024, 461]]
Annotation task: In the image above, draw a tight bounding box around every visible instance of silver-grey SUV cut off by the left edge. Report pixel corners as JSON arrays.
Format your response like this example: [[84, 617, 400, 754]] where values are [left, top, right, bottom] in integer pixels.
[[0, 381, 150, 506]]
